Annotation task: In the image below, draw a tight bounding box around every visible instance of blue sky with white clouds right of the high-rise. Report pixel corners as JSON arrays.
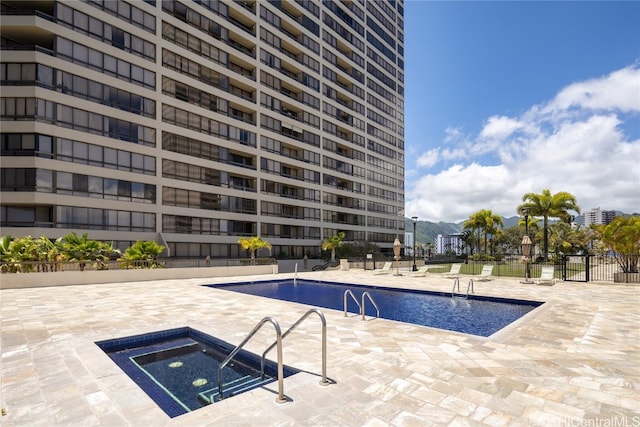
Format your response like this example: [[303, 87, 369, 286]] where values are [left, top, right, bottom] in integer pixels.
[[405, 0, 640, 222]]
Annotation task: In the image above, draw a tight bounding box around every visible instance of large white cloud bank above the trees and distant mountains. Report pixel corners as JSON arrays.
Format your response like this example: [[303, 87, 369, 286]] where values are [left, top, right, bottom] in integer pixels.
[[406, 67, 640, 222]]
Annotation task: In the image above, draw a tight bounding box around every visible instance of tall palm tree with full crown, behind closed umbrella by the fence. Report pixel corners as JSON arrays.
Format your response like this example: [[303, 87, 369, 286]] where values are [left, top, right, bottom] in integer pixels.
[[517, 189, 580, 261]]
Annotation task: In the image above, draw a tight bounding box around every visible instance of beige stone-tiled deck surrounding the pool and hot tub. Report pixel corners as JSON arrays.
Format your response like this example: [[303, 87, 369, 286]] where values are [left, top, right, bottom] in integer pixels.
[[0, 270, 640, 427]]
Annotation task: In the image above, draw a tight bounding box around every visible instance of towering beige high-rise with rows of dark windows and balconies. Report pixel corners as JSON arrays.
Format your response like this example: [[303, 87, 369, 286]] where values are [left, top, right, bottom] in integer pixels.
[[0, 0, 404, 258]]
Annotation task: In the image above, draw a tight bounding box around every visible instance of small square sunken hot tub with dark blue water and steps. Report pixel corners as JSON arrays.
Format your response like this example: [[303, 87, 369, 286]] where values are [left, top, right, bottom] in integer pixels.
[[96, 327, 297, 417]]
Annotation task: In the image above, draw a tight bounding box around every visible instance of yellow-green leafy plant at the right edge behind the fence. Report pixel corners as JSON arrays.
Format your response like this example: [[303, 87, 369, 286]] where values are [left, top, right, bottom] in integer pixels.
[[592, 216, 640, 273]]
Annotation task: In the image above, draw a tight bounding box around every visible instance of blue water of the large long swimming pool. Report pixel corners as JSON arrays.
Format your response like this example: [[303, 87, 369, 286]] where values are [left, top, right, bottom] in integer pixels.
[[207, 279, 542, 337]]
